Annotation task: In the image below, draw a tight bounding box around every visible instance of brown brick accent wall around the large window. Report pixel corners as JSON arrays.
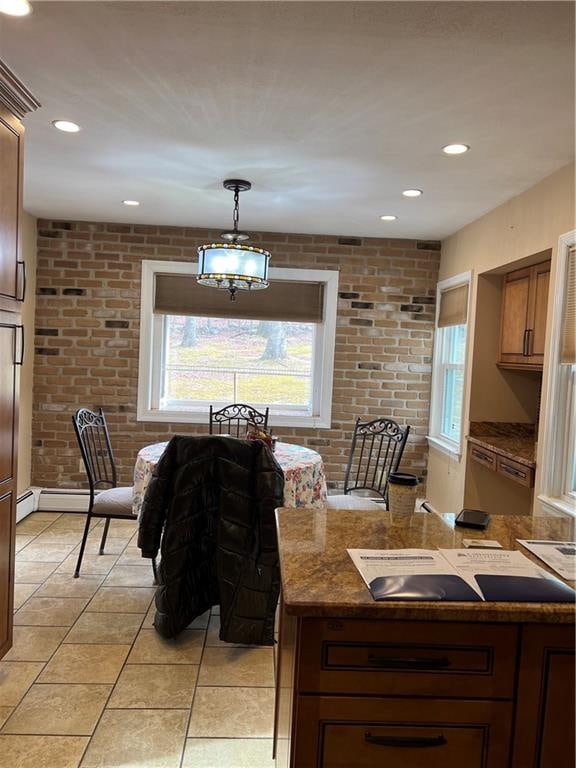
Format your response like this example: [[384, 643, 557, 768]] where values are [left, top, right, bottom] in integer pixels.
[[32, 220, 440, 488]]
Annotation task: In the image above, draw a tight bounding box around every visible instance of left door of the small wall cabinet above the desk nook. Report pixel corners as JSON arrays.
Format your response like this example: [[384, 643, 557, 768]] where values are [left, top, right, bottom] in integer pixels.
[[500, 268, 531, 365]]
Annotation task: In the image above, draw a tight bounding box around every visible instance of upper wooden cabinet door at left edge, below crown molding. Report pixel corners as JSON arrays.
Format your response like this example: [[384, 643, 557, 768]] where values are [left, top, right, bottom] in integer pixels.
[[0, 113, 21, 309]]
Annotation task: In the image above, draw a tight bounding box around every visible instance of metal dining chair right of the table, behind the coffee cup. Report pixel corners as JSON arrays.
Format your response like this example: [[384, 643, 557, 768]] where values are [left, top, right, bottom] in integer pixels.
[[327, 418, 410, 509]]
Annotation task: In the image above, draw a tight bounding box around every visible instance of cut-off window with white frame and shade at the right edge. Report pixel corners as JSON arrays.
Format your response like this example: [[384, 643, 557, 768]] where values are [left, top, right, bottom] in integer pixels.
[[538, 231, 576, 515]]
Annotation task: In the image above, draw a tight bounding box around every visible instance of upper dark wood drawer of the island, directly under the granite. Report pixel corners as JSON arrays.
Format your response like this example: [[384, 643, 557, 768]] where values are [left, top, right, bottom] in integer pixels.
[[298, 619, 517, 698]]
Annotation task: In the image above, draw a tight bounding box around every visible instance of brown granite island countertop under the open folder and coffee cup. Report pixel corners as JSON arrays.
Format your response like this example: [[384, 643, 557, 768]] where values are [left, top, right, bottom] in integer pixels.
[[276, 508, 574, 624]]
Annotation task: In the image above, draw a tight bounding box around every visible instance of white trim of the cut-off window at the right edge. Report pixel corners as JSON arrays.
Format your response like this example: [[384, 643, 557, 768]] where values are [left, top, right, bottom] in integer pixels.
[[538, 230, 576, 516]]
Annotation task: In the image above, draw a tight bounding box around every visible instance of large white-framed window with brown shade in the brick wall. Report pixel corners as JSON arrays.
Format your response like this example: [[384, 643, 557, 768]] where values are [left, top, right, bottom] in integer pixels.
[[138, 261, 338, 427]]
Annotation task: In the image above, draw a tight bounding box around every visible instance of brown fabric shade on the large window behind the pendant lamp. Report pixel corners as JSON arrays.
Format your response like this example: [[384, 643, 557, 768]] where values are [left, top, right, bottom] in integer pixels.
[[154, 274, 324, 323]]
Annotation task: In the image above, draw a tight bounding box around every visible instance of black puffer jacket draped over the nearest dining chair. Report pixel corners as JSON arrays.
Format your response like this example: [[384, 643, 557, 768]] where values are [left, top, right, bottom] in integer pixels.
[[138, 436, 284, 645]]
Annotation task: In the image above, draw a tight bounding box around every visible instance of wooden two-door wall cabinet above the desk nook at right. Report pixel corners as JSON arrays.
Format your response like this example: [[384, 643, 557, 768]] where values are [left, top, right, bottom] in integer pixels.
[[498, 260, 550, 370]]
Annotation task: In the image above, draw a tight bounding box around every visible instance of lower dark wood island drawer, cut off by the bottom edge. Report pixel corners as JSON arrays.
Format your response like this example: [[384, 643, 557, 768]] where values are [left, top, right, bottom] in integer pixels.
[[293, 696, 512, 768]]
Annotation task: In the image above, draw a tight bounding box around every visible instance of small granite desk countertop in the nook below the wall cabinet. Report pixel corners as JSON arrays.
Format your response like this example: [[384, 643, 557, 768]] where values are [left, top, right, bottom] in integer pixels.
[[468, 421, 536, 469]]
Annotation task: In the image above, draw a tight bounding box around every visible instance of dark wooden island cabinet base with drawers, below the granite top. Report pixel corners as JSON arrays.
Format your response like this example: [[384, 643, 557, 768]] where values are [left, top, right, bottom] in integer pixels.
[[275, 606, 574, 768]]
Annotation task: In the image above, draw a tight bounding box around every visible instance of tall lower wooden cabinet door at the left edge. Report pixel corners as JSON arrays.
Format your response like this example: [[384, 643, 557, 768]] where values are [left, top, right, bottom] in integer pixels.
[[0, 322, 18, 658]]
